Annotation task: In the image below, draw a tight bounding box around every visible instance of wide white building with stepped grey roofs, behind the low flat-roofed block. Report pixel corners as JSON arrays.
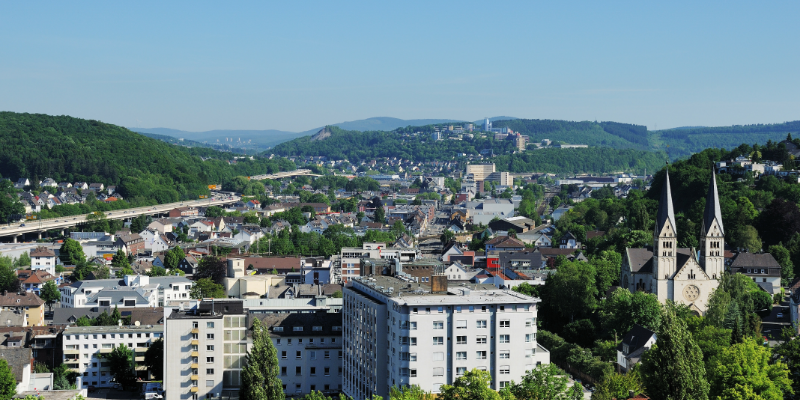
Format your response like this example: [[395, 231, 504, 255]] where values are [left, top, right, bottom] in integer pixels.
[[59, 275, 192, 308]]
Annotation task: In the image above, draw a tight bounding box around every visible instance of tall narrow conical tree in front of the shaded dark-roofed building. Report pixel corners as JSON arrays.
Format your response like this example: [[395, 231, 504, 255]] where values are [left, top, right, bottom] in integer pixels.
[[239, 318, 284, 400]]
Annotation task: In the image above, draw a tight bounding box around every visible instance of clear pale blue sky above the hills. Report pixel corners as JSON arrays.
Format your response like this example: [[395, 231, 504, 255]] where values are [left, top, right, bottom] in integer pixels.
[[0, 1, 800, 131]]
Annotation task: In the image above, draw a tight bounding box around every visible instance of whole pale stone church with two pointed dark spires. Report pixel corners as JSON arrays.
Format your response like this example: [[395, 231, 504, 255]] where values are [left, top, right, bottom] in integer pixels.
[[620, 169, 725, 315]]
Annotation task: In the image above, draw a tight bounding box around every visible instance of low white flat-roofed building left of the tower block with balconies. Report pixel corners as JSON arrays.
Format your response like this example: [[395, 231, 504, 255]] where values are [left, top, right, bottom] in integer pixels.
[[62, 325, 164, 389]]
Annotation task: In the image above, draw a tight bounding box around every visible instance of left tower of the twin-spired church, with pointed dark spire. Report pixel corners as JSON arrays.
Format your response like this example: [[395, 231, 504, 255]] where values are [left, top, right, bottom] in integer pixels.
[[653, 168, 678, 300]]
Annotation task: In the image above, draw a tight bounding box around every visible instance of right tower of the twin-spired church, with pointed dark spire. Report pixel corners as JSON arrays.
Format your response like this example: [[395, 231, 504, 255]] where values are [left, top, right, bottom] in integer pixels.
[[700, 167, 725, 279]]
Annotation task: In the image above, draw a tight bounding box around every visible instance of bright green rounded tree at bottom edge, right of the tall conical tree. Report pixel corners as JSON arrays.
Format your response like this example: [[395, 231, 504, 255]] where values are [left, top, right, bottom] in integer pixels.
[[708, 337, 792, 400]]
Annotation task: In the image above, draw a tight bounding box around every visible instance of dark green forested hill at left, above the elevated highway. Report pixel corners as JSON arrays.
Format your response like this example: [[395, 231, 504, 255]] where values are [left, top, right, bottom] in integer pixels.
[[0, 112, 295, 203]]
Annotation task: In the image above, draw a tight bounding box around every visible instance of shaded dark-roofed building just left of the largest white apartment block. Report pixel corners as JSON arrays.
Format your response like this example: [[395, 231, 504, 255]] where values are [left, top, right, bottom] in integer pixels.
[[258, 310, 344, 396]]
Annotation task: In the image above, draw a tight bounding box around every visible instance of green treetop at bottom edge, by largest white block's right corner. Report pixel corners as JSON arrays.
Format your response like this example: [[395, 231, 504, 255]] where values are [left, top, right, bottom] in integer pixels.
[[509, 364, 583, 400]]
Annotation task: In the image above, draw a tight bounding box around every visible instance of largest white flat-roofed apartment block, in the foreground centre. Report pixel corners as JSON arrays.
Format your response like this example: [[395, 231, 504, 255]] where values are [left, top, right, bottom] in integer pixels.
[[342, 275, 550, 400]]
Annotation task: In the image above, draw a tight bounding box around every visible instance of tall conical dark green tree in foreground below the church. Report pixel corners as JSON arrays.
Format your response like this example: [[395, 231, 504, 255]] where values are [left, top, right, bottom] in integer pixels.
[[641, 302, 709, 400]]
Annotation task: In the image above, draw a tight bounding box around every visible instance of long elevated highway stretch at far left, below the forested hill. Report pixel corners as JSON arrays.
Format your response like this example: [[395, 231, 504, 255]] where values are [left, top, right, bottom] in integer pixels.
[[0, 196, 241, 243]]
